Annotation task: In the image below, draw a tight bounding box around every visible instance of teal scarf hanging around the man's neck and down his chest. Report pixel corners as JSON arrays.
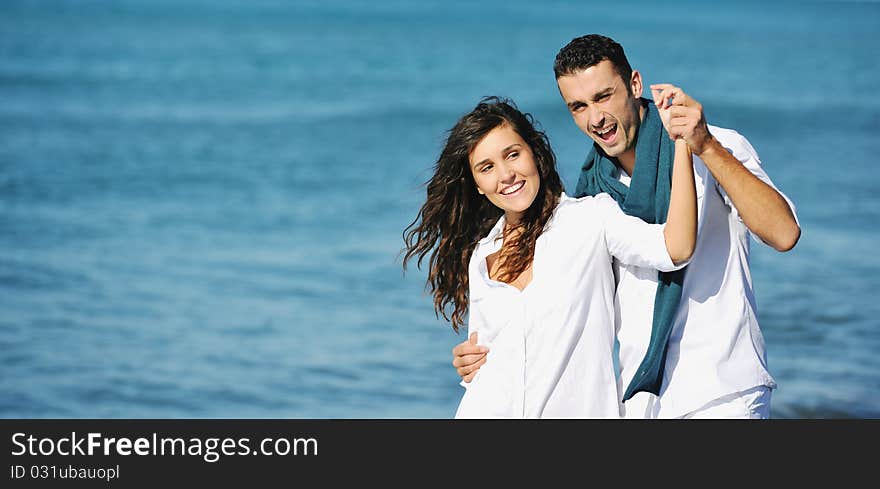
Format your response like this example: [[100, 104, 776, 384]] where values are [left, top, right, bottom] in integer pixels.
[[575, 98, 684, 401]]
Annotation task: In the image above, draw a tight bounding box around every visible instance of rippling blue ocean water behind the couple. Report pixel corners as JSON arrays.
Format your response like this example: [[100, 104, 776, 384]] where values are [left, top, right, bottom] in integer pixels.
[[0, 0, 880, 418]]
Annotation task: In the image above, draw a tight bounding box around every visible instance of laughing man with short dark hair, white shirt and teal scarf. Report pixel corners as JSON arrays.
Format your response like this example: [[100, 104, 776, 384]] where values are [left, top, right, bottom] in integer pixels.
[[453, 34, 800, 418]]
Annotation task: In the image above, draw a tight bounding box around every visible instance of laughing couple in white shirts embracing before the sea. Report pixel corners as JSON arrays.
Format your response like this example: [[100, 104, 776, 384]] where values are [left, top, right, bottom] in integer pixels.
[[404, 35, 800, 418]]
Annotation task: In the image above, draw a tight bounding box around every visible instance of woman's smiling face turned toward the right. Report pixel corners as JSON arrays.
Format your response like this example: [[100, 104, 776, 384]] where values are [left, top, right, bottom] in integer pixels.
[[469, 124, 541, 224]]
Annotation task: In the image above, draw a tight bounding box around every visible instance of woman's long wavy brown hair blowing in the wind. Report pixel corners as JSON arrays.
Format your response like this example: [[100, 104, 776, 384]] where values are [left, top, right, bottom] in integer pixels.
[[403, 97, 563, 332]]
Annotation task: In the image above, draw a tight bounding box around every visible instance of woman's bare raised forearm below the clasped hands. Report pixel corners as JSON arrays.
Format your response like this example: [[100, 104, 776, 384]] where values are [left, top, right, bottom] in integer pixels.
[[663, 138, 697, 264]]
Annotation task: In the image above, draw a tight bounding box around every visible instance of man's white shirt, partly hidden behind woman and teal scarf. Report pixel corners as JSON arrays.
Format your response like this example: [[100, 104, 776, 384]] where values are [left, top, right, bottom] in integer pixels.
[[614, 126, 797, 418]]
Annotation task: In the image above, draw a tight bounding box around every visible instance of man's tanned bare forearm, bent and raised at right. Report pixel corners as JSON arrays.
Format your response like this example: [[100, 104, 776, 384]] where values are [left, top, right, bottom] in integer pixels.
[[698, 137, 801, 251]]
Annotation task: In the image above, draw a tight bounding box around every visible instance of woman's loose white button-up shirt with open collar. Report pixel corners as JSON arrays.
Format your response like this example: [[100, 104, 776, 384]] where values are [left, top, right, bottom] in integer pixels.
[[455, 194, 684, 418]]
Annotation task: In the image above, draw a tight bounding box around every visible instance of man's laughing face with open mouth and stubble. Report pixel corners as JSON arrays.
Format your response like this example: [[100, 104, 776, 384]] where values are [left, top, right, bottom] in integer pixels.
[[556, 59, 642, 158]]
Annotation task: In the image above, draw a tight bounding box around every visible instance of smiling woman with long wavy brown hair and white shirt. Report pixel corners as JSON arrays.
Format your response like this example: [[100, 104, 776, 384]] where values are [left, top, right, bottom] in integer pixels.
[[404, 97, 696, 418]]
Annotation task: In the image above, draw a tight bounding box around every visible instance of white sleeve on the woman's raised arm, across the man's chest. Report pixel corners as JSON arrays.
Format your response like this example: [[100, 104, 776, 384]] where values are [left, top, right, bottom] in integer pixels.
[[596, 195, 688, 272]]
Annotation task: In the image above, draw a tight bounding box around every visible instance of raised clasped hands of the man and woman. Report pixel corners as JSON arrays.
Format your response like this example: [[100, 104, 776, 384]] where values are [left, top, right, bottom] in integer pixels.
[[651, 83, 715, 156]]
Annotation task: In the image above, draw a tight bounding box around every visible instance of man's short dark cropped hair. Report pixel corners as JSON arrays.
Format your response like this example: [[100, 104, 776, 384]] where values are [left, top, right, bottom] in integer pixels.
[[553, 34, 632, 87]]
